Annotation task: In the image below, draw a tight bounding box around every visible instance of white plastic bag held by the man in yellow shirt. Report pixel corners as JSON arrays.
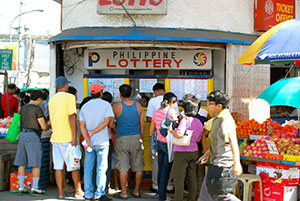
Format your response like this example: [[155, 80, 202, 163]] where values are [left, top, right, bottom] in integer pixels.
[[65, 144, 82, 169]]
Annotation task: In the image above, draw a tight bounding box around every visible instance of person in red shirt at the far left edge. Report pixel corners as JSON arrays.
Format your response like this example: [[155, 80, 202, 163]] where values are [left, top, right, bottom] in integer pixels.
[[1, 84, 19, 118]]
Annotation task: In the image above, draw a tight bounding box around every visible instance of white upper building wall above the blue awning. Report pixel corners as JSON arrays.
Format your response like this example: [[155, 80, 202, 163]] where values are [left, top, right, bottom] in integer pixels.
[[62, 0, 254, 33]]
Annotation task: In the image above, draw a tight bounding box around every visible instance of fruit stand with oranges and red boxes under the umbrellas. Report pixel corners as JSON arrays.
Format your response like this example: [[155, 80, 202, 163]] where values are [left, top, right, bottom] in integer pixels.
[[237, 119, 300, 201]]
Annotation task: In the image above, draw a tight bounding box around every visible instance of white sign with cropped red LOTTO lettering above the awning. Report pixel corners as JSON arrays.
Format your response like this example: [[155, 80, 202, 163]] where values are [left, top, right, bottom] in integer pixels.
[[97, 0, 167, 15]]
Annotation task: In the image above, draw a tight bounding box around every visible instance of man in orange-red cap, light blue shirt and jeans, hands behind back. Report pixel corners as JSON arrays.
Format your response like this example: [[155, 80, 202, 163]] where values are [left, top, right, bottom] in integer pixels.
[[79, 83, 114, 201]]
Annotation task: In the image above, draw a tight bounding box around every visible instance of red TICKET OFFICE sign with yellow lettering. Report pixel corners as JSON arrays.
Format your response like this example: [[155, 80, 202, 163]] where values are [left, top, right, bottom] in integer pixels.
[[254, 0, 295, 31]]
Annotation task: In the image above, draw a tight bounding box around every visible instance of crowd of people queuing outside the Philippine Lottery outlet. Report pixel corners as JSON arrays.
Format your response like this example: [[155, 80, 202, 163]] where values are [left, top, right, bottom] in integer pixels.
[[1, 76, 242, 201]]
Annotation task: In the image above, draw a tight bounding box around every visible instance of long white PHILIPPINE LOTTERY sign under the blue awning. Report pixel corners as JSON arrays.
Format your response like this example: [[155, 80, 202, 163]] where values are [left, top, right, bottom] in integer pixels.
[[84, 50, 212, 70]]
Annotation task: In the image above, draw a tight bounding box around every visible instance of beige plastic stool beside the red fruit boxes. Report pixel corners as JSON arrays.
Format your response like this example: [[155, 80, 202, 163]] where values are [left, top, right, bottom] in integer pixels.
[[238, 174, 263, 201]]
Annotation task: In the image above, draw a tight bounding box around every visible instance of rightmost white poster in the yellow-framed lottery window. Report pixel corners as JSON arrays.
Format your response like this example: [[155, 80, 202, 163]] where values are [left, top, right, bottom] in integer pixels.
[[170, 79, 208, 101]]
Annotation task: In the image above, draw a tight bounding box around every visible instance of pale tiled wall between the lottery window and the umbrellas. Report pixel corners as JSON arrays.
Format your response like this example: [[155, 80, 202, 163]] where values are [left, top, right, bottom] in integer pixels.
[[226, 44, 270, 121]]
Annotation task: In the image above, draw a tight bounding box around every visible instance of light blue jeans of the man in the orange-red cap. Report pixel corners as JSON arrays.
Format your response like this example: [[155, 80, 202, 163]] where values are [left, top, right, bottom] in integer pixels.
[[84, 145, 109, 199]]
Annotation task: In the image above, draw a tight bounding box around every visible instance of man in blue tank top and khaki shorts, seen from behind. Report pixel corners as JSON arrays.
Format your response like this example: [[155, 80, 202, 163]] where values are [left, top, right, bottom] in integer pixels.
[[113, 84, 145, 199]]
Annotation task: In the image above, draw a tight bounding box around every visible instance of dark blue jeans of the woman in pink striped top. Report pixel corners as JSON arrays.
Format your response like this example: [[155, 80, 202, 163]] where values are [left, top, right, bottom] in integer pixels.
[[157, 140, 172, 201]]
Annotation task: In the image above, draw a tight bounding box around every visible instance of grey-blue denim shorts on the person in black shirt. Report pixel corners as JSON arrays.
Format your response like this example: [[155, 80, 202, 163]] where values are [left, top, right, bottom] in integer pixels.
[[14, 130, 42, 168]]
